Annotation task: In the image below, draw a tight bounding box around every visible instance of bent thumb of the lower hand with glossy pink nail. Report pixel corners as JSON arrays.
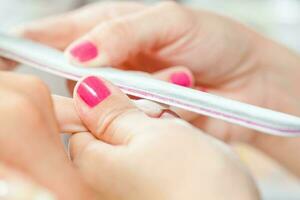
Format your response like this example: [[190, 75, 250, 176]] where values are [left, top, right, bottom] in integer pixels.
[[74, 76, 148, 144]]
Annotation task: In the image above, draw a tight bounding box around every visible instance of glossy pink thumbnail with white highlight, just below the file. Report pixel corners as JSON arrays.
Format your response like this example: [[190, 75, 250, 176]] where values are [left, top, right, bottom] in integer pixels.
[[77, 76, 110, 108]]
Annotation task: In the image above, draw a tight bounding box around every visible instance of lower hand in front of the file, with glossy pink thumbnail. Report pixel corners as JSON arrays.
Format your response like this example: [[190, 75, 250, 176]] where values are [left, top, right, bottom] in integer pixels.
[[56, 77, 258, 200]]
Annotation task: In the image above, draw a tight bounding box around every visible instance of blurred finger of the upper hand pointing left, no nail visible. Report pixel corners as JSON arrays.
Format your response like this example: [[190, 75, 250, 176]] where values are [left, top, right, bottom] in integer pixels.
[[14, 2, 144, 50]]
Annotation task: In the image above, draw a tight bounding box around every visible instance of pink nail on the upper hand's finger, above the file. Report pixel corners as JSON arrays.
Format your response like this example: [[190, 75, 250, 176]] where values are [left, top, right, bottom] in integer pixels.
[[70, 41, 98, 62]]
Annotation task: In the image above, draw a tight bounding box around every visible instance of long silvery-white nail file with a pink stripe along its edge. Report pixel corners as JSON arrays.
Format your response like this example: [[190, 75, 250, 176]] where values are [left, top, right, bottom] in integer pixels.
[[0, 34, 300, 136]]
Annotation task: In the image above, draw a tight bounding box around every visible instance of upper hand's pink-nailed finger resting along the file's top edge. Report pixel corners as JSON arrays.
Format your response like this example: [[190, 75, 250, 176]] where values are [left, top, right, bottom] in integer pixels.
[[66, 1, 191, 66]]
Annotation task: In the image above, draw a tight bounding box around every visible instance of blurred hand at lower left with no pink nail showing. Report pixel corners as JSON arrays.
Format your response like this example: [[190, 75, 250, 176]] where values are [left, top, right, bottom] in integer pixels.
[[0, 72, 93, 200]]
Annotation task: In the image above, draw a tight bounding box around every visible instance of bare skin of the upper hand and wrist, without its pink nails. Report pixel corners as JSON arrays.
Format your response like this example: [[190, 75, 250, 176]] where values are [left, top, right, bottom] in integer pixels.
[[3, 2, 300, 175]]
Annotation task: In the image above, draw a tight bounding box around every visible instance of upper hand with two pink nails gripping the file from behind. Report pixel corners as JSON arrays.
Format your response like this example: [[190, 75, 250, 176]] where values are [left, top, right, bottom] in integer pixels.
[[0, 2, 288, 142]]
